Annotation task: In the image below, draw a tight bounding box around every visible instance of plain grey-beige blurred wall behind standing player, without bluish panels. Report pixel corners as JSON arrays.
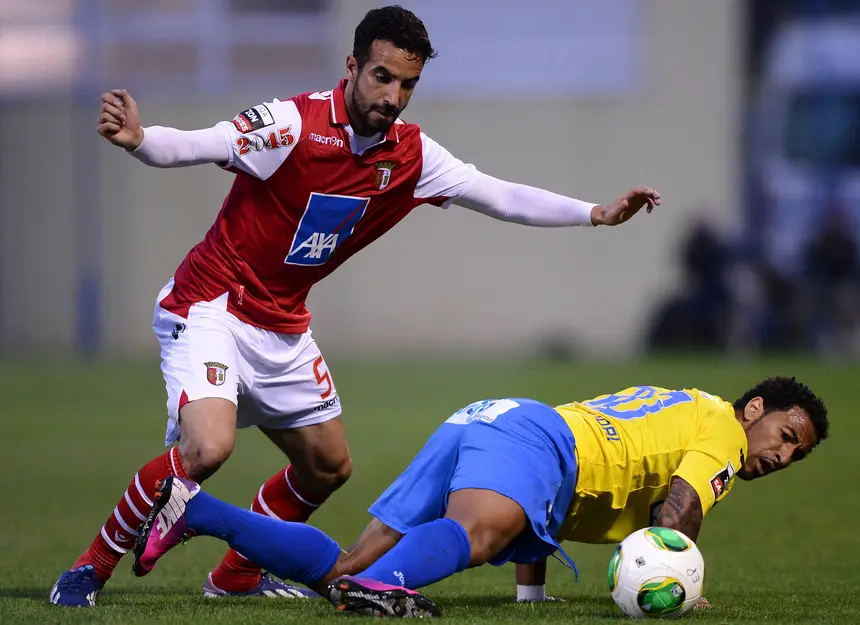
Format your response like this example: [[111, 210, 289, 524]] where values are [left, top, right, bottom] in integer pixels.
[[0, 0, 742, 357]]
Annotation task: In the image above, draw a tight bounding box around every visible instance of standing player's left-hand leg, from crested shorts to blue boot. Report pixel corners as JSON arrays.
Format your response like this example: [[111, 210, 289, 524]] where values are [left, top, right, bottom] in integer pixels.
[[50, 285, 239, 606]]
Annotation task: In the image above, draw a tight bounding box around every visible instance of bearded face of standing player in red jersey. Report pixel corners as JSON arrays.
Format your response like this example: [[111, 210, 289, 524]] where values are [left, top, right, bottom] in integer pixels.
[[345, 40, 424, 136]]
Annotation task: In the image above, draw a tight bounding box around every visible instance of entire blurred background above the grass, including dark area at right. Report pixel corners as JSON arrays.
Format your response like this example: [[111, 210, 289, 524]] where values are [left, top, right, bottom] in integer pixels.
[[0, 0, 860, 358]]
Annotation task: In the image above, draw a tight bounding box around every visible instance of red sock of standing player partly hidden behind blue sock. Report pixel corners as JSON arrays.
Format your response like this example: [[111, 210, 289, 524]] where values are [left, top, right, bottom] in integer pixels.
[[212, 465, 322, 592]]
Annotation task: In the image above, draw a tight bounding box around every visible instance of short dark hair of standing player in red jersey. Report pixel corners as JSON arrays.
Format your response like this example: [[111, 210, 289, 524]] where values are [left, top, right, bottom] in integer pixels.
[[352, 5, 436, 71]]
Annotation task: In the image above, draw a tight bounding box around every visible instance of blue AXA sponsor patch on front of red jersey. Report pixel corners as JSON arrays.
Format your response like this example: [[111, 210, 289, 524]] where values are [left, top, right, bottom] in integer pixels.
[[284, 193, 370, 267]]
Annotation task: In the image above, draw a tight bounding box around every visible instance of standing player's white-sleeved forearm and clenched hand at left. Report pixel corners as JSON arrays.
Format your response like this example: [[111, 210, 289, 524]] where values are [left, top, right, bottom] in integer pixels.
[[97, 89, 231, 168]]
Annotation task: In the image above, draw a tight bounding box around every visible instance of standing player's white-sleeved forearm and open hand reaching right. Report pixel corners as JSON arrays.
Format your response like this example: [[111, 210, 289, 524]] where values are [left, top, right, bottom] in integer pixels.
[[456, 171, 660, 227]]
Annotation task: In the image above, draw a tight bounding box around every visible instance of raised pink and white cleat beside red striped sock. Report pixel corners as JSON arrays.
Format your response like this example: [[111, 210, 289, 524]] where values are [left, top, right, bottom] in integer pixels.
[[131, 476, 200, 577]]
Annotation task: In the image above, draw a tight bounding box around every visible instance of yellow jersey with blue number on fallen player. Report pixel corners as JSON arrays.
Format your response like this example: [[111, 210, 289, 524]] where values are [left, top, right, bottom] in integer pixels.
[[556, 386, 747, 543]]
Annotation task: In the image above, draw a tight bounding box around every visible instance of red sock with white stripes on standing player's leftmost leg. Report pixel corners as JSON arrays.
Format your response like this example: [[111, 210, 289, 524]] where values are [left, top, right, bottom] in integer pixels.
[[72, 447, 188, 581]]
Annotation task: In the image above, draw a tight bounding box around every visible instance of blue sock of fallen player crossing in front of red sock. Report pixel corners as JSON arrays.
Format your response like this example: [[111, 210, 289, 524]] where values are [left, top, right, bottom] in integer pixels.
[[186, 492, 341, 584]]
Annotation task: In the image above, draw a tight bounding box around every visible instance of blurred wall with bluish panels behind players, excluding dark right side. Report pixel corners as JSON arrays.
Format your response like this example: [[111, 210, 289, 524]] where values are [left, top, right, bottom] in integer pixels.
[[0, 0, 744, 358]]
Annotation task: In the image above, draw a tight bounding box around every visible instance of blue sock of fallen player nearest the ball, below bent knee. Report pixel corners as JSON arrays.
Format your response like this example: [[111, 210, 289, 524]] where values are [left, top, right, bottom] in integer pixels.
[[358, 519, 472, 588]]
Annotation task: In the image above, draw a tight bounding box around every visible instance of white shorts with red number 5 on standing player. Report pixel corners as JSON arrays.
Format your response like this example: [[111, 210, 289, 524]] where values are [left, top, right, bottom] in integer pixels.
[[152, 279, 341, 445]]
